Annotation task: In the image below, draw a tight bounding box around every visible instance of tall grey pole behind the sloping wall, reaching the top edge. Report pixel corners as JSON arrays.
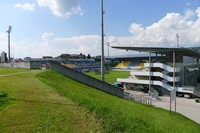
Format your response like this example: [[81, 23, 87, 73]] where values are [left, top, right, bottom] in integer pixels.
[[101, 0, 104, 82]]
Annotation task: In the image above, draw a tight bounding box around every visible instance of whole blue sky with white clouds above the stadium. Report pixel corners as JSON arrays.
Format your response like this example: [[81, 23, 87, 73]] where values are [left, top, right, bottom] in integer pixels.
[[0, 0, 200, 58]]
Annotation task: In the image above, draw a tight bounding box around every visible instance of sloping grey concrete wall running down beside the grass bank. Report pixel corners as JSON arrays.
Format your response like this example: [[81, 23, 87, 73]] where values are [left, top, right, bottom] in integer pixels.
[[49, 61, 124, 98]]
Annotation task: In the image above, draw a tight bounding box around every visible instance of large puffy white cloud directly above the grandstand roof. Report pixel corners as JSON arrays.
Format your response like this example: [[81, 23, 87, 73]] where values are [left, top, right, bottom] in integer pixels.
[[123, 7, 200, 47]]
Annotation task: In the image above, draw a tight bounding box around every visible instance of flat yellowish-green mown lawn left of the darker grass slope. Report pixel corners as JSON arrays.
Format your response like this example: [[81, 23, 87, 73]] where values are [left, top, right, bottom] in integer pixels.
[[0, 69, 101, 133]]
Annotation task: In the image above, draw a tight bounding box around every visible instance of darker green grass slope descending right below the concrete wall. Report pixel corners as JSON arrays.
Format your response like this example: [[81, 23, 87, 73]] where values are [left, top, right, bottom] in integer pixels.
[[37, 70, 200, 133]]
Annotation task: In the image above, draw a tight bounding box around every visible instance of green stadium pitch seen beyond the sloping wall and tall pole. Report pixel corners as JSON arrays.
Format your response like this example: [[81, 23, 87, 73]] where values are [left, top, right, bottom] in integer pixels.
[[86, 70, 130, 83]]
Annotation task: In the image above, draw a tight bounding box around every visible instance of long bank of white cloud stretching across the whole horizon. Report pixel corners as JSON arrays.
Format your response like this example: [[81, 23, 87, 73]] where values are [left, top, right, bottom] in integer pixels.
[[0, 7, 200, 57]]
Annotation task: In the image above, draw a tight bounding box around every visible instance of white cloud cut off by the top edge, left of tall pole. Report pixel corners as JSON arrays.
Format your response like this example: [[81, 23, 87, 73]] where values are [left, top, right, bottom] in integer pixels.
[[37, 0, 82, 17]]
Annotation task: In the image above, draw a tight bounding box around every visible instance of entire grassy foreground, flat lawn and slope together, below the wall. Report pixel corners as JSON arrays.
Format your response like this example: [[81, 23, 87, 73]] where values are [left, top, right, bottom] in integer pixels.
[[0, 69, 200, 133]]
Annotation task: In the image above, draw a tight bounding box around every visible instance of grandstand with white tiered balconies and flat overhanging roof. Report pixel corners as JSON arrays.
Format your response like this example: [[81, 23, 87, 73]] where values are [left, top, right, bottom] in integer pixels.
[[112, 47, 200, 97]]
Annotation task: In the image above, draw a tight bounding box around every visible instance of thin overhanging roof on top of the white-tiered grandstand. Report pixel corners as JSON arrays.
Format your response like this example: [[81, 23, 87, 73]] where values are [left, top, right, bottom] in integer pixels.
[[112, 46, 200, 58]]
